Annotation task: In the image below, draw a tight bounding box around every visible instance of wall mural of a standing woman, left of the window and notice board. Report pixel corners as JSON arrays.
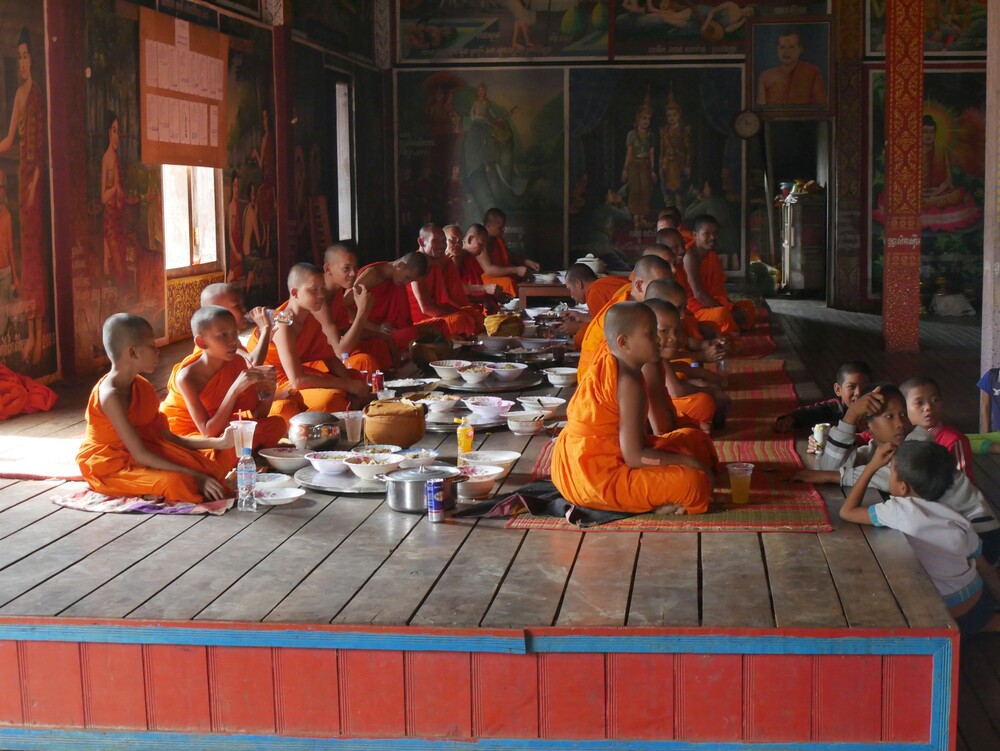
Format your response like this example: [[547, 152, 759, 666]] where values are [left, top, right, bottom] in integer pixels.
[[82, 0, 166, 368]]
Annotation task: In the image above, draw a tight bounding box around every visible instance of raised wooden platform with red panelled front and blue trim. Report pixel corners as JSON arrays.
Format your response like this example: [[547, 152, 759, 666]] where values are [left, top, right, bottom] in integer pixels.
[[0, 304, 995, 750]]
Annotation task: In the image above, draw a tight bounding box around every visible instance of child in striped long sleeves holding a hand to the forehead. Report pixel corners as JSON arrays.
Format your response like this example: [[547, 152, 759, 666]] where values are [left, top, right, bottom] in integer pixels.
[[794, 383, 1000, 563]]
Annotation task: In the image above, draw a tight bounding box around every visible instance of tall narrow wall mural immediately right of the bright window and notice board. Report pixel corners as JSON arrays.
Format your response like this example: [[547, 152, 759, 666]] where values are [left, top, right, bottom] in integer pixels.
[[223, 21, 283, 307]]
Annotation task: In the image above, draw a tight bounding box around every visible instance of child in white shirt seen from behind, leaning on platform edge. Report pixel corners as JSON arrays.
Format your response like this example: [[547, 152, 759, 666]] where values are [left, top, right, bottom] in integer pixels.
[[840, 441, 1000, 637]]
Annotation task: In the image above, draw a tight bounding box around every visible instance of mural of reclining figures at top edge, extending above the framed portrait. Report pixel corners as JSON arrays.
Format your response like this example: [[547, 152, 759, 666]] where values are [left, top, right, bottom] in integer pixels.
[[614, 0, 828, 58]]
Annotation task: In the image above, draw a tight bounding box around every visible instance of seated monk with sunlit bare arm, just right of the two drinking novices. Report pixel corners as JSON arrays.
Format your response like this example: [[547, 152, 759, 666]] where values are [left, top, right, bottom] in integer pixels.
[[250, 263, 371, 422]]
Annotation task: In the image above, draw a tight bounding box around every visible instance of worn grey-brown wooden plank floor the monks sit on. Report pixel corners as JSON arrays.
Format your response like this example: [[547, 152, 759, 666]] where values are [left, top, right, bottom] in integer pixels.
[[0, 301, 1000, 751]]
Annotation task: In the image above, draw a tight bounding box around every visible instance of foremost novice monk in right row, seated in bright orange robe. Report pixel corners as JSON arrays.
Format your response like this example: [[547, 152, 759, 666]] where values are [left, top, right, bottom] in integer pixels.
[[552, 301, 717, 514]]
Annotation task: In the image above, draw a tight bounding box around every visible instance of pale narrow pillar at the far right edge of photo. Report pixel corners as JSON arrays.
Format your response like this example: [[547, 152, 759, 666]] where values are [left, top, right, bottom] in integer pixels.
[[979, 4, 1000, 430]]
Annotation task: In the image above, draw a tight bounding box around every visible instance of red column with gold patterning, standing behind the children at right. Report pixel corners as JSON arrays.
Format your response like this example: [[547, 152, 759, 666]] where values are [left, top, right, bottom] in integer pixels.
[[882, 0, 924, 352]]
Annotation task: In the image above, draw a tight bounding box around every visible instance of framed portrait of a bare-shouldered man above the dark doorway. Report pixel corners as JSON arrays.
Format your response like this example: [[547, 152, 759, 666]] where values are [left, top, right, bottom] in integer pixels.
[[747, 16, 833, 118]]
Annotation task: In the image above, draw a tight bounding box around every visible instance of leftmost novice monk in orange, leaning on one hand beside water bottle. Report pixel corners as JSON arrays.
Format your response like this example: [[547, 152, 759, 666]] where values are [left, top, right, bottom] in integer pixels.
[[76, 313, 233, 503]]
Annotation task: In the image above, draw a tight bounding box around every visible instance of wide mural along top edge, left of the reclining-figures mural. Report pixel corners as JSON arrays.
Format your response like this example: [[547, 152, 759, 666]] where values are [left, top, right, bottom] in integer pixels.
[[397, 0, 613, 62]]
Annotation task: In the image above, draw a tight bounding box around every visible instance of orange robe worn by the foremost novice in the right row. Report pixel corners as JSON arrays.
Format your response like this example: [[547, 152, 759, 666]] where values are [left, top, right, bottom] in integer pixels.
[[552, 346, 718, 514]]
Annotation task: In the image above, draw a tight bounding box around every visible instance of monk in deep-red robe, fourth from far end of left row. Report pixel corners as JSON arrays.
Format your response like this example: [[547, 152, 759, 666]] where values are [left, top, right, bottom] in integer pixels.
[[406, 224, 483, 338]]
